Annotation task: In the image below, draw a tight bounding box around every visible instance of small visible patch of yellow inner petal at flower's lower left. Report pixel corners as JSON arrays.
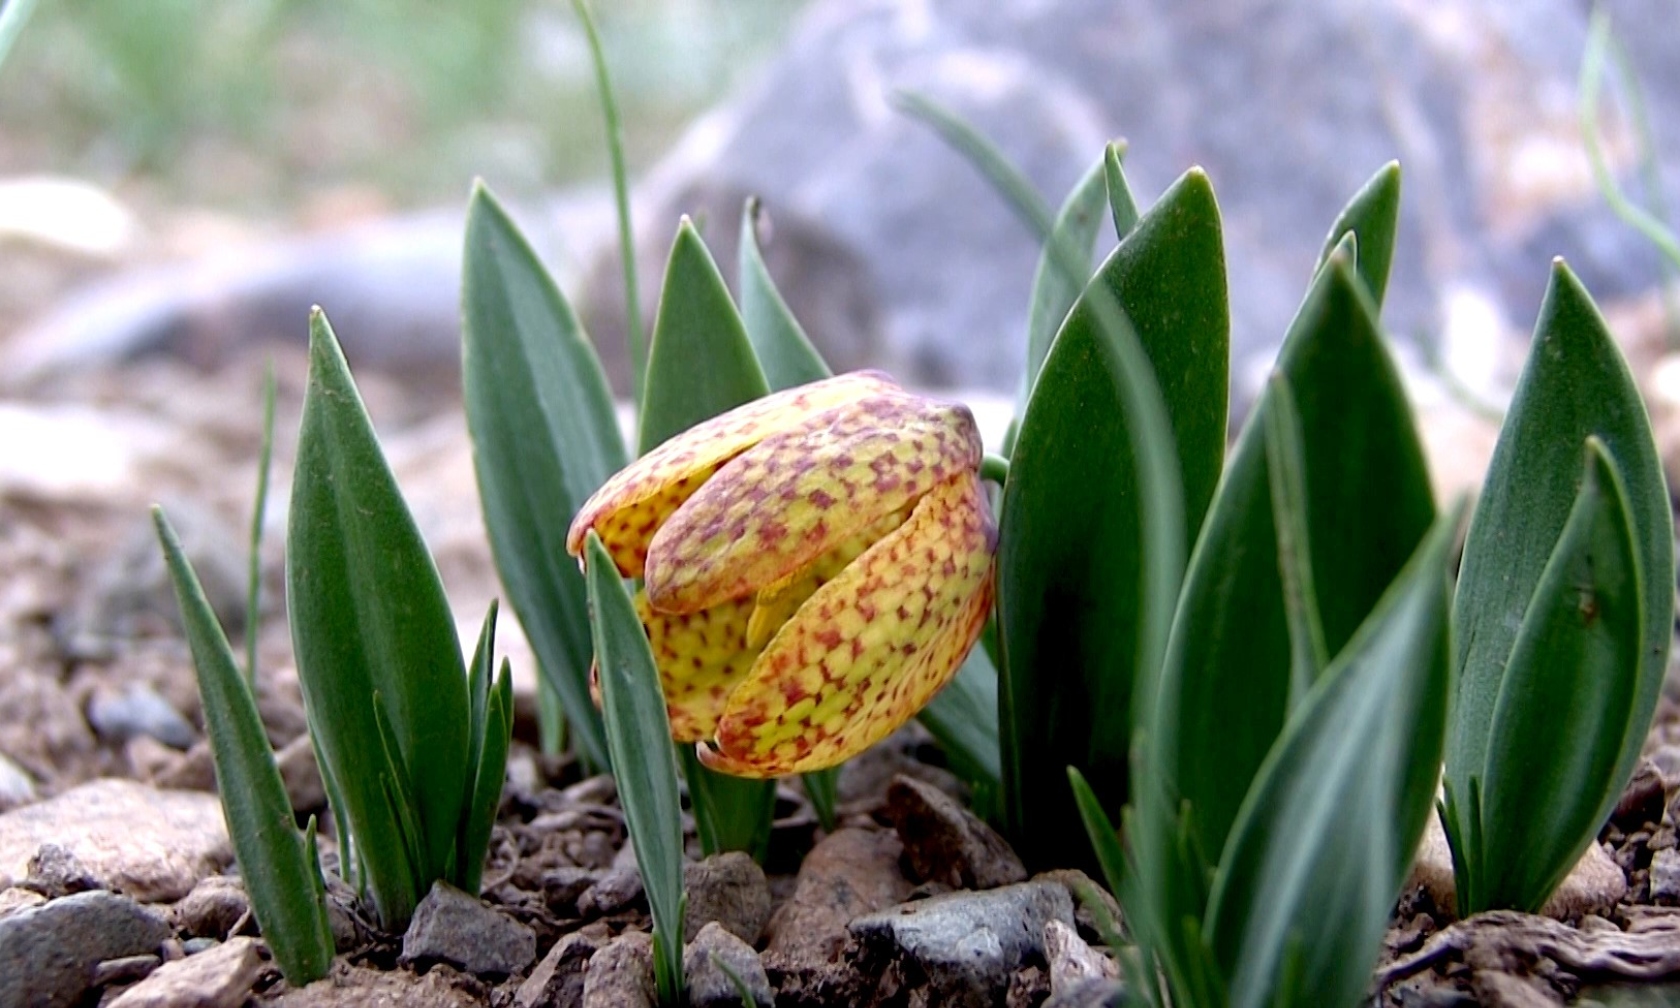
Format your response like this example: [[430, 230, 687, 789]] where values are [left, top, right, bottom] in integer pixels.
[[635, 591, 759, 743]]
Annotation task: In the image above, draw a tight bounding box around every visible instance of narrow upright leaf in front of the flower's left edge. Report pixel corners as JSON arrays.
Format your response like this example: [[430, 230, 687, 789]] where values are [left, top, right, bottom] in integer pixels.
[[583, 529, 684, 1005]]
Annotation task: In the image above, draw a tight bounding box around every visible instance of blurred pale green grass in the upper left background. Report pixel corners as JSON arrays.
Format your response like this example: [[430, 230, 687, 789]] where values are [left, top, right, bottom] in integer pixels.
[[0, 0, 805, 217]]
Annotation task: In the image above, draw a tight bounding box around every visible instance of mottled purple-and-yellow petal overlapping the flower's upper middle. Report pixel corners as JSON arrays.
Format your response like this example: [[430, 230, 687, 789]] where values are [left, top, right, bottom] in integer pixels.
[[645, 393, 981, 613]]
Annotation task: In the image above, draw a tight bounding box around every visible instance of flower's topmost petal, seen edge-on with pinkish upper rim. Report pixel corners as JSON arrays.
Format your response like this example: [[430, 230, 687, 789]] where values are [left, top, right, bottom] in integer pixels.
[[566, 371, 899, 578]]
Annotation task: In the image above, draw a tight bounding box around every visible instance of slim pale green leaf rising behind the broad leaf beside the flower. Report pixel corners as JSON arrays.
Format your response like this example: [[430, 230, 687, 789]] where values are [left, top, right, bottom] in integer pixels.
[[1015, 150, 1107, 417]]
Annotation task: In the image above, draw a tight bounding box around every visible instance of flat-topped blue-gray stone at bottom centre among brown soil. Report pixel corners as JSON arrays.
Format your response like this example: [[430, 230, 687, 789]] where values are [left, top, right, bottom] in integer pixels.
[[850, 882, 1074, 1006]]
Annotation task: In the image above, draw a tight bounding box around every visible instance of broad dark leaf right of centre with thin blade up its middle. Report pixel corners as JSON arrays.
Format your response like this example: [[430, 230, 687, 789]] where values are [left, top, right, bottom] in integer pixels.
[[1137, 252, 1435, 981]]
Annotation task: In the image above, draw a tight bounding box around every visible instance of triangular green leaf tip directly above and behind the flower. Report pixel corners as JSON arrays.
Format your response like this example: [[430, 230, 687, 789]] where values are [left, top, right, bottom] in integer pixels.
[[641, 217, 769, 453]]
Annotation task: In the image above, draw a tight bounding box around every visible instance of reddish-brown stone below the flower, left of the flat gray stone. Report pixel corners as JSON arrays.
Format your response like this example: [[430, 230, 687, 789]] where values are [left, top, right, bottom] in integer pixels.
[[764, 827, 911, 971]]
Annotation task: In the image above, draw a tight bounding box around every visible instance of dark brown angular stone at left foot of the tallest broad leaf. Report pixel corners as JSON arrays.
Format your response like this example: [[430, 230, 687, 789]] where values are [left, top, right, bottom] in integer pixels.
[[887, 776, 1026, 889]]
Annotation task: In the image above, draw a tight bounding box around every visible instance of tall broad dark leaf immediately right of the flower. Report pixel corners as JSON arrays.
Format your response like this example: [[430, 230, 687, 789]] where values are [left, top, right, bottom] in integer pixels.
[[998, 171, 1228, 865]]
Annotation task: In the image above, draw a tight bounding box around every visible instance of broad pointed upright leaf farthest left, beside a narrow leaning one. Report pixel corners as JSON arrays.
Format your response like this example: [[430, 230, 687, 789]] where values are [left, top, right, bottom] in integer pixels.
[[286, 309, 467, 929]]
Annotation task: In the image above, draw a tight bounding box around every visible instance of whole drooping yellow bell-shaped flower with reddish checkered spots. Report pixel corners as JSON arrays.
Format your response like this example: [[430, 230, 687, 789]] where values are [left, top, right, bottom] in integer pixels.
[[566, 371, 996, 778]]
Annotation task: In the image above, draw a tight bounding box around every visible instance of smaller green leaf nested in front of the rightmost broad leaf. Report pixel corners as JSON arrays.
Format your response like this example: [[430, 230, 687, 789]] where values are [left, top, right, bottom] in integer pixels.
[[1460, 438, 1645, 914]]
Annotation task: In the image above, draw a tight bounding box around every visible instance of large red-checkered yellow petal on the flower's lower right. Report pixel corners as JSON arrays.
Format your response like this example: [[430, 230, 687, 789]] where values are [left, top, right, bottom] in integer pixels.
[[699, 474, 996, 778]]
